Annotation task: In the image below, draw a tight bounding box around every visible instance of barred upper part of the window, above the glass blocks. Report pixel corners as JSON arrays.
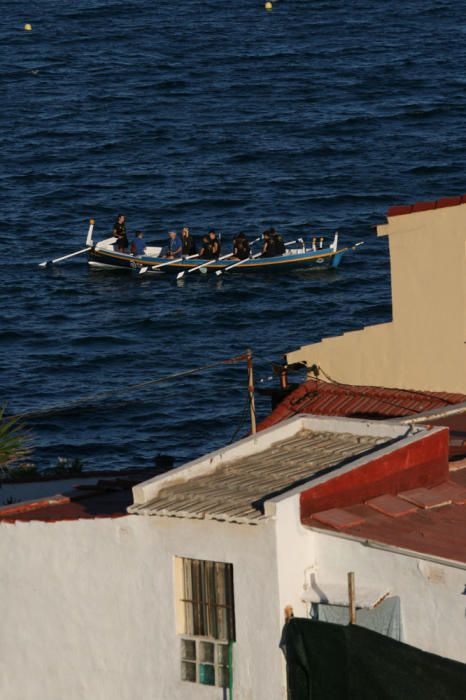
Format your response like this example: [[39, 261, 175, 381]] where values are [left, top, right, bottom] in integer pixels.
[[181, 559, 235, 641]]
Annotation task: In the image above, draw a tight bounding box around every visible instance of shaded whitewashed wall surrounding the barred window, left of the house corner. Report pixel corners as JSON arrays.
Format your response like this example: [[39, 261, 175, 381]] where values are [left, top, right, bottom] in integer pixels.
[[0, 516, 285, 700]]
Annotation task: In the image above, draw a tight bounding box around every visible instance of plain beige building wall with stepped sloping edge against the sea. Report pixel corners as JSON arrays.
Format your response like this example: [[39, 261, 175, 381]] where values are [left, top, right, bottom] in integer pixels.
[[287, 204, 466, 393]]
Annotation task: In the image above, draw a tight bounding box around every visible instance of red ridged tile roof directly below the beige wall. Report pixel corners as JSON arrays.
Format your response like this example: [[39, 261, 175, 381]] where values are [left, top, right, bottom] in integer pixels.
[[257, 379, 466, 454]]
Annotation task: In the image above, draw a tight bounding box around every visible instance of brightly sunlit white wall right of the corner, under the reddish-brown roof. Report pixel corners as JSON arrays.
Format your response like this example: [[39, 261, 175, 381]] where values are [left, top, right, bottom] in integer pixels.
[[276, 495, 466, 663]]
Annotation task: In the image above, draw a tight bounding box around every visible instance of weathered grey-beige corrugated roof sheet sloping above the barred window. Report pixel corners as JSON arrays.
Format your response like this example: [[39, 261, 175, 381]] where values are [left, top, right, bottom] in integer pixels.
[[130, 430, 387, 523]]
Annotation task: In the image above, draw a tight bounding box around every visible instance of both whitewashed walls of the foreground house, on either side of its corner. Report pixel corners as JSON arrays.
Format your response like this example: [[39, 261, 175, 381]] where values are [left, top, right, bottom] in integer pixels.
[[0, 482, 466, 700]]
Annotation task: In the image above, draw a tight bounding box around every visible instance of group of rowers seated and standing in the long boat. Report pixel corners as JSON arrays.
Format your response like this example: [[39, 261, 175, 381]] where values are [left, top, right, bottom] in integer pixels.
[[112, 214, 285, 260]]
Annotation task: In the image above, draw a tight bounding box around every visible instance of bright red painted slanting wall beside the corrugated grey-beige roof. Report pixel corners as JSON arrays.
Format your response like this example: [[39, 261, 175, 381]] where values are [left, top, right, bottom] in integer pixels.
[[300, 428, 449, 521]]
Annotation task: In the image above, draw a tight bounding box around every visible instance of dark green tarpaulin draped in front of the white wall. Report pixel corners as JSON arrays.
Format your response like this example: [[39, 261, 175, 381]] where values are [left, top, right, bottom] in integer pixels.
[[286, 618, 466, 700]]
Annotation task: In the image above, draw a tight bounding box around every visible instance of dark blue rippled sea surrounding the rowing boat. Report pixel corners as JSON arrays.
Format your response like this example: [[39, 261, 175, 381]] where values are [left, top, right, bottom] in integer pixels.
[[0, 0, 466, 469]]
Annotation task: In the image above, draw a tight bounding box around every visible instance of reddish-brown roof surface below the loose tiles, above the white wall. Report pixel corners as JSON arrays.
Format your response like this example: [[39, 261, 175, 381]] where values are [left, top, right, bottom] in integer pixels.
[[303, 469, 466, 563]]
